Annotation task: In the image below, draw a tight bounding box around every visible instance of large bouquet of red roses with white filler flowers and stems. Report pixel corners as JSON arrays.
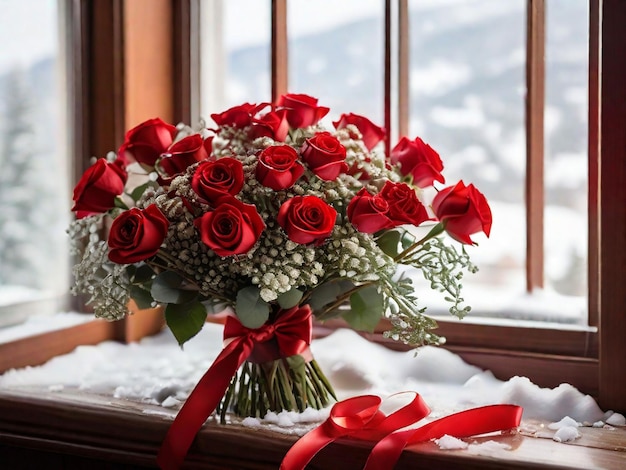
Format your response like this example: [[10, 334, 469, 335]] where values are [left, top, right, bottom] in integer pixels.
[[69, 94, 491, 426]]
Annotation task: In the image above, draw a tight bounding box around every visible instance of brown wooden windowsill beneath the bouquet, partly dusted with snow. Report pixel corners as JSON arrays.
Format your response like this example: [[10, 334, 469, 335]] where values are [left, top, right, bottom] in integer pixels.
[[0, 387, 626, 470]]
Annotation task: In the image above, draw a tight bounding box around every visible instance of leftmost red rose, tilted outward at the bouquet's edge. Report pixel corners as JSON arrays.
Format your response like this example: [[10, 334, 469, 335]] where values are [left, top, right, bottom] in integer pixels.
[[72, 158, 127, 218]]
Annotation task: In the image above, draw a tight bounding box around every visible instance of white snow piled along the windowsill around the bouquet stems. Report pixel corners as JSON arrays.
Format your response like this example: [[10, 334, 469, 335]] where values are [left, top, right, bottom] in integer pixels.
[[0, 322, 626, 451]]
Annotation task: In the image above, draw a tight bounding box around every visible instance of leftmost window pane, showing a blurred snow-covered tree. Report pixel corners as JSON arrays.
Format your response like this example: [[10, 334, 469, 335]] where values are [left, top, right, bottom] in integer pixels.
[[0, 0, 70, 324]]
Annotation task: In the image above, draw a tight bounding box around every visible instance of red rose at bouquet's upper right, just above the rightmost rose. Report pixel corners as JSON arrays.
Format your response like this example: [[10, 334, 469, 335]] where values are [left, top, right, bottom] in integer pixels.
[[391, 137, 446, 188]]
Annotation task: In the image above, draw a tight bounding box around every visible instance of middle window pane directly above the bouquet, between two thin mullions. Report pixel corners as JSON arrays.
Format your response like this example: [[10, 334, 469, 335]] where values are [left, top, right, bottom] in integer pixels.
[[287, 0, 385, 126]]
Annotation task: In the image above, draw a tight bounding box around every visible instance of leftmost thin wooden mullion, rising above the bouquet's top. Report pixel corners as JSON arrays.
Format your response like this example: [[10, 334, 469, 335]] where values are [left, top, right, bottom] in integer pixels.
[[272, 0, 289, 103]]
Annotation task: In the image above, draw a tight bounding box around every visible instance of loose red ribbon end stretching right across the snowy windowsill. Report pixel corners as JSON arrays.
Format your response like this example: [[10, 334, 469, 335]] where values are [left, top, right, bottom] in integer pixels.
[[364, 405, 523, 470]]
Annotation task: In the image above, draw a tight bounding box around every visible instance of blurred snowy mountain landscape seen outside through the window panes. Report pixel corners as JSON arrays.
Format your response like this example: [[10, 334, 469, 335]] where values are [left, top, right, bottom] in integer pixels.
[[0, 0, 587, 325]]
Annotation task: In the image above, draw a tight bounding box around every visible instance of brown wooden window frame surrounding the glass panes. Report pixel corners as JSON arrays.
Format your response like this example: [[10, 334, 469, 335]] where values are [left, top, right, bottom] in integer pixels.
[[0, 0, 626, 418]]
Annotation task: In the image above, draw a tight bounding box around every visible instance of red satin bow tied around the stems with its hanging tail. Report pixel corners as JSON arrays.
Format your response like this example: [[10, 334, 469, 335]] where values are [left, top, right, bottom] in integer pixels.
[[157, 305, 312, 470]]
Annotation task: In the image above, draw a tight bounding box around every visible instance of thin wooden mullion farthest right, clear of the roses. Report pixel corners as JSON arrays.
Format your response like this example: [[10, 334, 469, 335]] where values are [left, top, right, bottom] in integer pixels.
[[526, 0, 546, 292]]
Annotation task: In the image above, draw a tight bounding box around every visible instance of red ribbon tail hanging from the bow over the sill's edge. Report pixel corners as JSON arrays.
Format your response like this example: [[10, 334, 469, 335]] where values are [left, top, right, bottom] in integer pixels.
[[157, 337, 252, 470]]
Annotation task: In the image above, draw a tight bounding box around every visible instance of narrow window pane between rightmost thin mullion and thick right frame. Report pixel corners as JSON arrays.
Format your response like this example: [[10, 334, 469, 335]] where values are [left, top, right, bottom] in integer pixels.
[[545, 0, 589, 305]]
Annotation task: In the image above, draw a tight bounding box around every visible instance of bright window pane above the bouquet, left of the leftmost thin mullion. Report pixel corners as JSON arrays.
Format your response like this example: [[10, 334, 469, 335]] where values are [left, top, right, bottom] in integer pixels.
[[200, 0, 272, 117]]
